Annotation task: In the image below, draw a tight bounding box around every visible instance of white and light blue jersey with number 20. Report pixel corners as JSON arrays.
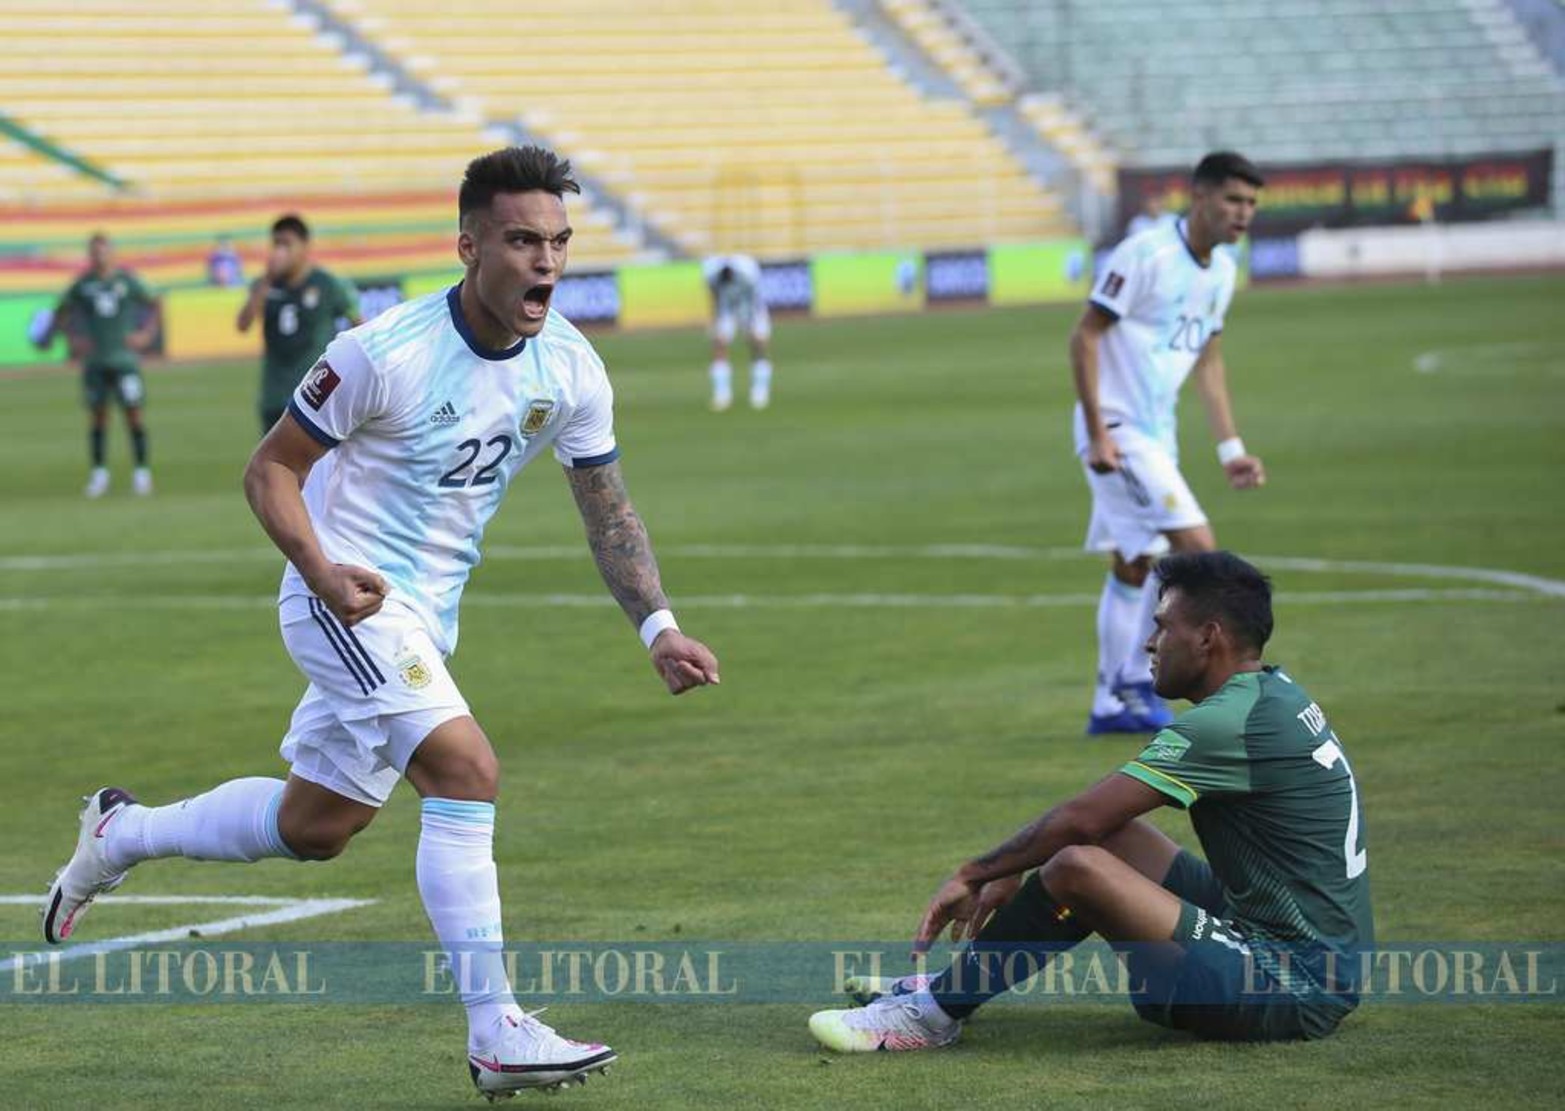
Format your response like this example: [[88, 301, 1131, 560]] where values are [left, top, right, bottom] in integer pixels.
[[1075, 219, 1236, 457]]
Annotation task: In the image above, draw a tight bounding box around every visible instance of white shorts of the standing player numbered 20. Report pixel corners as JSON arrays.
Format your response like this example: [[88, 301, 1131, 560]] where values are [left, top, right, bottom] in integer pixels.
[[1081, 427, 1207, 562]]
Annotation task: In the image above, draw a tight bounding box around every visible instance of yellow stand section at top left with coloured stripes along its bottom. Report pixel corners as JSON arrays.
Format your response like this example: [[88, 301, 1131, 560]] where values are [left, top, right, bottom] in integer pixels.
[[0, 0, 635, 289]]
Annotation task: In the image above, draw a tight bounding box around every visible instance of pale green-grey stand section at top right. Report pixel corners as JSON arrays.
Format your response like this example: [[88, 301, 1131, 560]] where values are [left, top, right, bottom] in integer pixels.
[[962, 0, 1565, 164]]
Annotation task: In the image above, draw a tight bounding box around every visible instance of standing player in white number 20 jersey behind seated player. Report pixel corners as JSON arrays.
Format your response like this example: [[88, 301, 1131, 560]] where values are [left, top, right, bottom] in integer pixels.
[[1070, 152, 1266, 734]]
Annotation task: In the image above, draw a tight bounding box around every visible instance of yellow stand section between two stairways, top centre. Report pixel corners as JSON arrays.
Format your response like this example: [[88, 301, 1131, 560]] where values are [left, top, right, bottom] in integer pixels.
[[329, 0, 1069, 255]]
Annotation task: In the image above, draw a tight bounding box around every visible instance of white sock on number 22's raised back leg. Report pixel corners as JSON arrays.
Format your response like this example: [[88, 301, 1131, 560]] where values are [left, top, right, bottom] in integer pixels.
[[103, 776, 294, 868]]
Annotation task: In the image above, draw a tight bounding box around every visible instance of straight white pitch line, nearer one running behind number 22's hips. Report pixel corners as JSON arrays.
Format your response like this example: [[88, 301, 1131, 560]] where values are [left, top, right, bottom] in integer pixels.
[[0, 587, 1538, 613]]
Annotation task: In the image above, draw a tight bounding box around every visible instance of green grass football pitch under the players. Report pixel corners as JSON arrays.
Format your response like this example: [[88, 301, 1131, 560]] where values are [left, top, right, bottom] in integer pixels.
[[0, 277, 1565, 1111]]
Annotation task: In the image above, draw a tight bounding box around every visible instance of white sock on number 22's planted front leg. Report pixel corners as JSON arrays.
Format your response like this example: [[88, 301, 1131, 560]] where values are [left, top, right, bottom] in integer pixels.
[[418, 798, 521, 1050]]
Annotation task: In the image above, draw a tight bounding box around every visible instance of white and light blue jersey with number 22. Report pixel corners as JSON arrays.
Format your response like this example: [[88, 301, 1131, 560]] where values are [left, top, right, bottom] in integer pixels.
[[282, 285, 618, 653]]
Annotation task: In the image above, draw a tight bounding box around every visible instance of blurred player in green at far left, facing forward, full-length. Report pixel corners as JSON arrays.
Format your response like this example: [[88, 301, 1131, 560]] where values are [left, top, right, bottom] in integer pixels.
[[38, 232, 163, 498]]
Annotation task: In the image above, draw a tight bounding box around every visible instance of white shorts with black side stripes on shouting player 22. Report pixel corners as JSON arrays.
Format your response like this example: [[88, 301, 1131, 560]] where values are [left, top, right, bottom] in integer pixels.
[[279, 595, 470, 806]]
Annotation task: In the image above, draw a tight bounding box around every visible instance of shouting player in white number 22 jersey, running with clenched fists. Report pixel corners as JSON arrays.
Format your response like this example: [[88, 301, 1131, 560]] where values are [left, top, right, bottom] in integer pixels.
[[44, 147, 718, 1098]]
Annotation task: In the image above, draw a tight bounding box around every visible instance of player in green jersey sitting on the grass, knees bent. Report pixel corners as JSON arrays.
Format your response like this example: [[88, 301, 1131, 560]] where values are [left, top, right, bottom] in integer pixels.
[[809, 551, 1374, 1052]]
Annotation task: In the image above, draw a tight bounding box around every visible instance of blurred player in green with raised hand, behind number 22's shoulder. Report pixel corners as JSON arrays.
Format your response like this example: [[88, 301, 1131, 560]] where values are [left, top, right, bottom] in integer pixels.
[[236, 214, 362, 437]]
